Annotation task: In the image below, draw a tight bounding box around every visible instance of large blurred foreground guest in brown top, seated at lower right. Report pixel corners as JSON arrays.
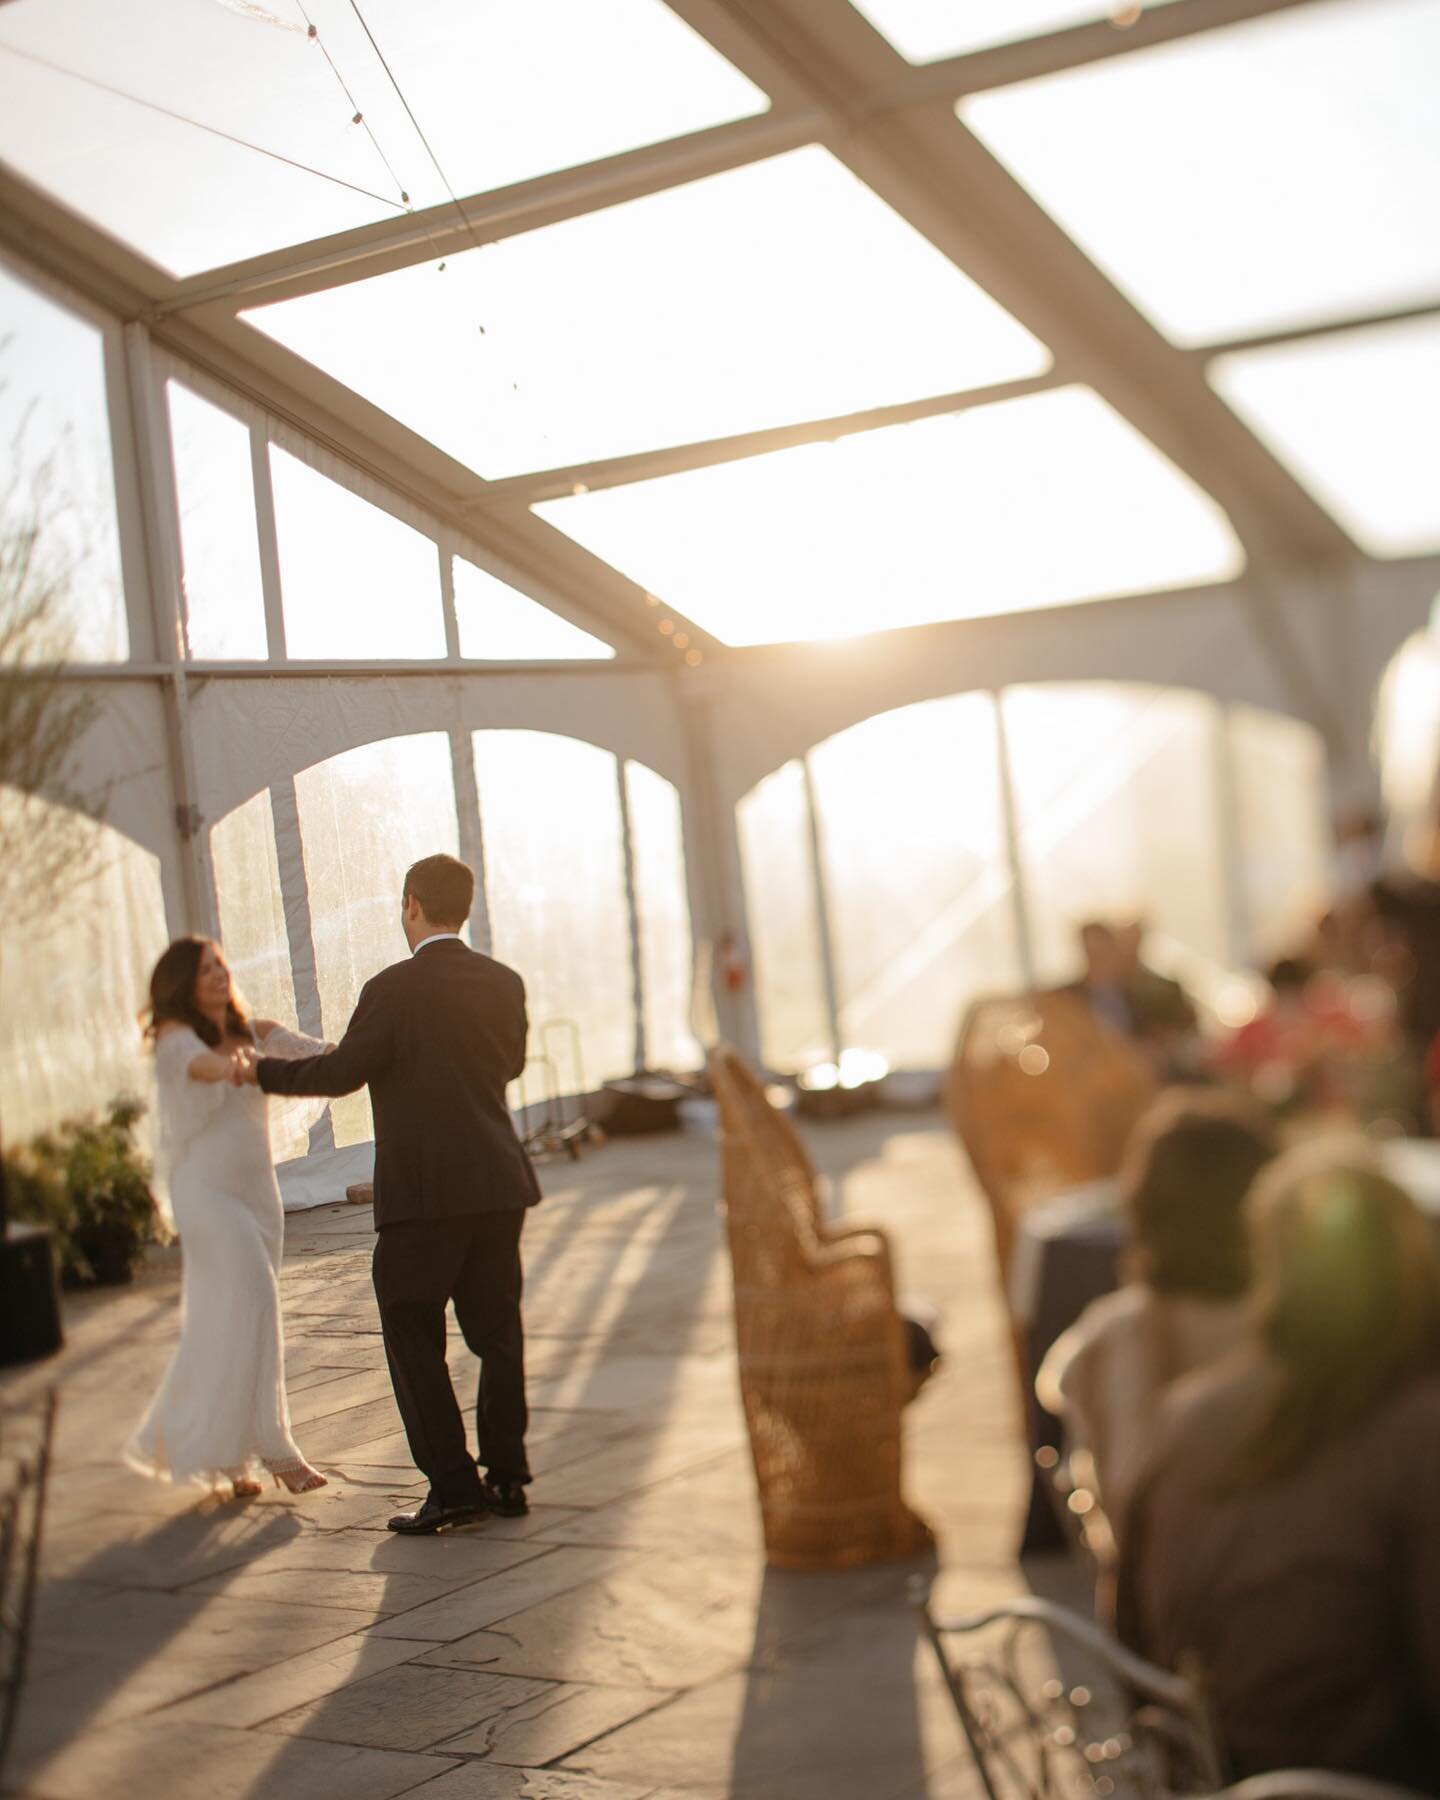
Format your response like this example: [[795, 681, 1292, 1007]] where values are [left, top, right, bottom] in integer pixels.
[[1118, 1143, 1440, 1795]]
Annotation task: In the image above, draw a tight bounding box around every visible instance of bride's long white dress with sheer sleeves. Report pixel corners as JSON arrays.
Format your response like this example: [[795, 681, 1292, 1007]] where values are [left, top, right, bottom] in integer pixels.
[[126, 1028, 326, 1485]]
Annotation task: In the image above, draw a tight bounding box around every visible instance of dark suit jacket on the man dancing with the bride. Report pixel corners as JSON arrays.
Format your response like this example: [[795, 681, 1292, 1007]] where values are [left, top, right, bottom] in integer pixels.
[[257, 938, 540, 1229]]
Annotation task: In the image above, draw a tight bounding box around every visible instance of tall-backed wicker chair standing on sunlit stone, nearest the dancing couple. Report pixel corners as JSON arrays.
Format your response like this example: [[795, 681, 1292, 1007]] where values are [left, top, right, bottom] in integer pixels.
[[711, 1046, 931, 1570]]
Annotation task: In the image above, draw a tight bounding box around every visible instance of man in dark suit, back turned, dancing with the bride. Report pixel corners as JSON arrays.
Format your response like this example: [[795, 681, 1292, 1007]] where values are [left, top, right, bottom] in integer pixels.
[[250, 855, 540, 1532]]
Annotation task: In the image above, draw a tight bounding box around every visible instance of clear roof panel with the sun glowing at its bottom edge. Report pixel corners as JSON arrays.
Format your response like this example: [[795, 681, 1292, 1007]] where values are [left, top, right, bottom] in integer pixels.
[[535, 387, 1242, 644]]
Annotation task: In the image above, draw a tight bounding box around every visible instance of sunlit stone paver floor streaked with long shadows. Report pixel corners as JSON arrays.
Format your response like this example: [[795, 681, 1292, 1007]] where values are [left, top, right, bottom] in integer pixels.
[[0, 1114, 1058, 1800]]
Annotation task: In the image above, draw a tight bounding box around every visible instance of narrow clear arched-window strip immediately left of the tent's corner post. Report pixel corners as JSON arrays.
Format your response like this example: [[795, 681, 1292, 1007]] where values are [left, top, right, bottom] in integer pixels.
[[625, 763, 706, 1069]]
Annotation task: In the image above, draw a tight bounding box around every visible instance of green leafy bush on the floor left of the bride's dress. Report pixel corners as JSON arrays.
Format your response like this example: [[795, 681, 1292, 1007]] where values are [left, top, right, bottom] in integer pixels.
[[5, 1094, 157, 1287]]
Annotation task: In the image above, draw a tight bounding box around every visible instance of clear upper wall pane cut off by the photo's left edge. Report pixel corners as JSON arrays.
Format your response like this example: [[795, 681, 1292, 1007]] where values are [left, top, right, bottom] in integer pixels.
[[0, 263, 130, 662]]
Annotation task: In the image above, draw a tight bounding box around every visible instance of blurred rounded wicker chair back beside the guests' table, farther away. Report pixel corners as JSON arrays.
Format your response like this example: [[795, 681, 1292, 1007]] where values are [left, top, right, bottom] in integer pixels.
[[945, 990, 1157, 1292]]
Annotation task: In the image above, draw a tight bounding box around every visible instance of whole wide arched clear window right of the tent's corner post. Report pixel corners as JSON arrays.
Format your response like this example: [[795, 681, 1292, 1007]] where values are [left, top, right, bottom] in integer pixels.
[[720, 680, 1330, 1069]]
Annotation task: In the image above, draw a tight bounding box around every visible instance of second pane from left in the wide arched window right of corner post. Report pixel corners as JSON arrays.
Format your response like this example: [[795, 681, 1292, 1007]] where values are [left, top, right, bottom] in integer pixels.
[[808, 693, 1021, 1069]]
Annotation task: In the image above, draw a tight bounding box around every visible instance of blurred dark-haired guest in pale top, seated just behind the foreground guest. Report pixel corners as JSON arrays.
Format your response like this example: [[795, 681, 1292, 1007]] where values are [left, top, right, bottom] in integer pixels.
[[1035, 1089, 1276, 1548]]
